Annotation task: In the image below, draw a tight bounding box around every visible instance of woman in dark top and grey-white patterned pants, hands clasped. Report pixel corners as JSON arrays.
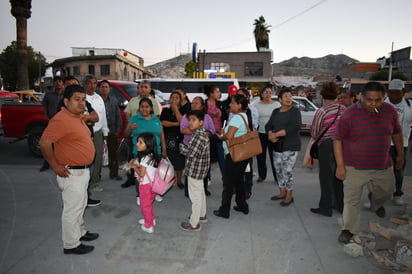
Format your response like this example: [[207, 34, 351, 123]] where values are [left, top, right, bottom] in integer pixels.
[[265, 89, 302, 206]]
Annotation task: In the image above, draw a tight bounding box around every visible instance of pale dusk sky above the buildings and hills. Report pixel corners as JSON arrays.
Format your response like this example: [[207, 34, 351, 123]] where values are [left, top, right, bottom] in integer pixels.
[[0, 0, 412, 66]]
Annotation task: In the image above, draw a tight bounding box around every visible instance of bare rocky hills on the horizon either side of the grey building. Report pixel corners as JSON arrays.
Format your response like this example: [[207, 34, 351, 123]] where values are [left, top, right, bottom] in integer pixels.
[[147, 54, 358, 78]]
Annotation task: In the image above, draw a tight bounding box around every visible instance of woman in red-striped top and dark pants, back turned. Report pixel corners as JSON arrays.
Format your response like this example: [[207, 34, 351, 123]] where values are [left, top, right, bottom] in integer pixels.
[[310, 82, 345, 217]]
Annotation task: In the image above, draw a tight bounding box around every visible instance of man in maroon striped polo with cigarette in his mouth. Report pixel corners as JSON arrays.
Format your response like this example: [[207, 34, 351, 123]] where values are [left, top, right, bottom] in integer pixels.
[[333, 82, 404, 243]]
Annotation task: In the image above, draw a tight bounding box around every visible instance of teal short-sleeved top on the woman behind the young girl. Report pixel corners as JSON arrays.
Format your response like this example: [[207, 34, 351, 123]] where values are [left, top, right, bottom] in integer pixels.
[[129, 113, 162, 154]]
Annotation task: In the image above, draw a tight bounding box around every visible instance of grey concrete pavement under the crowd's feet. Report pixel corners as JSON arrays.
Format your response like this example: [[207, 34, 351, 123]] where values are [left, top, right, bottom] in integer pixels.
[[0, 161, 412, 274]]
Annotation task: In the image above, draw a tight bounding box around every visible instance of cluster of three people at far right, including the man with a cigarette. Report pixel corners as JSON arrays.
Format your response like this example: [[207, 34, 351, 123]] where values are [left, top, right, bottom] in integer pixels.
[[308, 79, 412, 243]]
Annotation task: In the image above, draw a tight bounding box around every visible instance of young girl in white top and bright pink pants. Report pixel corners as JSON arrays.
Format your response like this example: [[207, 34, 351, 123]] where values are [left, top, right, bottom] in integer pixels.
[[129, 132, 160, 233]]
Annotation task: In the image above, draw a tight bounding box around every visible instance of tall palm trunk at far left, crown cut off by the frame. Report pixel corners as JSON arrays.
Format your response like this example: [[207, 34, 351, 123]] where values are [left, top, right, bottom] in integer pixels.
[[10, 0, 31, 90]]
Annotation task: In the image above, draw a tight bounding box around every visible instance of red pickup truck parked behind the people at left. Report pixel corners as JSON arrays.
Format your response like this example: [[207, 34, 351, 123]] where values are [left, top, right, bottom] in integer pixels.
[[0, 81, 163, 156]]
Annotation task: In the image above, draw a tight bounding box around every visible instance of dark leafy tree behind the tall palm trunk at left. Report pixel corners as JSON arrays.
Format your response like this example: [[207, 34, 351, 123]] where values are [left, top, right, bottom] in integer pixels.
[[0, 41, 47, 91]]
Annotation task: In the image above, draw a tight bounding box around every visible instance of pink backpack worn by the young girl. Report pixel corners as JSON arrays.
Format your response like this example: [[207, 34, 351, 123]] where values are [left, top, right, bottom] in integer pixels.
[[146, 158, 176, 195]]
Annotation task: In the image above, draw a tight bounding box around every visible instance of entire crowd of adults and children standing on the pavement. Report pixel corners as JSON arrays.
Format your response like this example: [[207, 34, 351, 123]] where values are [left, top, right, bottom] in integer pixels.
[[40, 75, 412, 254]]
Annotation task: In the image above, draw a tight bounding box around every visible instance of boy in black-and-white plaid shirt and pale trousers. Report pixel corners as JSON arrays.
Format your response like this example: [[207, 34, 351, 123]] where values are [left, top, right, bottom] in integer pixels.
[[180, 110, 210, 231]]
